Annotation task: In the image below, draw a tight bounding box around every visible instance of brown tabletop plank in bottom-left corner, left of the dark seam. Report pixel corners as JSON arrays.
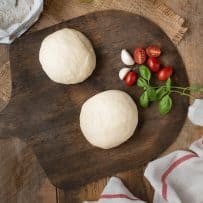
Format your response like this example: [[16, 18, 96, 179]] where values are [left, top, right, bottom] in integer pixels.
[[0, 138, 56, 203]]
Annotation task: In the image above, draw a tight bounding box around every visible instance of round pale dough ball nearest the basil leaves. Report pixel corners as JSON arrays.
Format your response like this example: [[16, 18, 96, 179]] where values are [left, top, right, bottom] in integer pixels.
[[80, 90, 138, 149]]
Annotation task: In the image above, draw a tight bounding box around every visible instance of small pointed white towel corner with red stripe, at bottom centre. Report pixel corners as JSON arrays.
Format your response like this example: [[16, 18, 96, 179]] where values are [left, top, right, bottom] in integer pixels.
[[83, 177, 145, 203]]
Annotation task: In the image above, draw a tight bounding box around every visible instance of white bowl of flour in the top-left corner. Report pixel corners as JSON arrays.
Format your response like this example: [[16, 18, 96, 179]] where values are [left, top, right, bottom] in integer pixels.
[[0, 0, 44, 44]]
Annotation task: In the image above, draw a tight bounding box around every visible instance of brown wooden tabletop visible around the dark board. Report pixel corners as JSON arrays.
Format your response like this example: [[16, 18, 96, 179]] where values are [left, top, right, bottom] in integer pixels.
[[0, 0, 203, 203]]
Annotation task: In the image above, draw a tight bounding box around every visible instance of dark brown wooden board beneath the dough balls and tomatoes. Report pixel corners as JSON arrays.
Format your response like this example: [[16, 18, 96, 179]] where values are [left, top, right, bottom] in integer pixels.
[[0, 10, 189, 189]]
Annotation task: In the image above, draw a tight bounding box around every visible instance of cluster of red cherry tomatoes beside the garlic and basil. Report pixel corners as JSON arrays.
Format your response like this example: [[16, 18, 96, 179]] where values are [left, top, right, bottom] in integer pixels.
[[124, 45, 173, 86]]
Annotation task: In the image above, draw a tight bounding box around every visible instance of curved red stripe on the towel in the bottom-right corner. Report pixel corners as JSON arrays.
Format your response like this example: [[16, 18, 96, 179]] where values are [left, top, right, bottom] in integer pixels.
[[161, 154, 197, 200]]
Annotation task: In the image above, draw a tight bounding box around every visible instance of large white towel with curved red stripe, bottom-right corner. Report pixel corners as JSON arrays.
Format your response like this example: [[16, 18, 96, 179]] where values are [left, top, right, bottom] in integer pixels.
[[144, 138, 203, 203]]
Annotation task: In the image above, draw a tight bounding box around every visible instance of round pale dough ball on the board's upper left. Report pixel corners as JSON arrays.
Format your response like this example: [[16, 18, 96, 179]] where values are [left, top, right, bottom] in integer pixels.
[[39, 28, 96, 84]]
